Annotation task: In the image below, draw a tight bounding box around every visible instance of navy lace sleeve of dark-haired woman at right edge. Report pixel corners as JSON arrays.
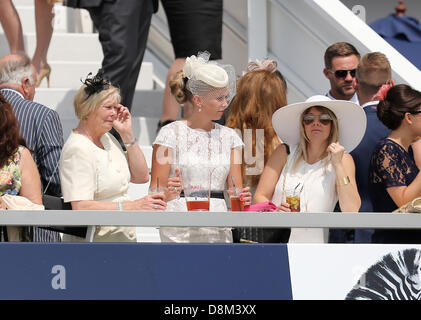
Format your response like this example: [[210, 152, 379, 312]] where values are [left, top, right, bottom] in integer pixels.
[[373, 144, 408, 188]]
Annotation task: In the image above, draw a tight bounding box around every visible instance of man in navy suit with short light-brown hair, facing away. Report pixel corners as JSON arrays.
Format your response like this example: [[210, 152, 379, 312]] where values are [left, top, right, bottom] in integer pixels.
[[329, 52, 393, 243]]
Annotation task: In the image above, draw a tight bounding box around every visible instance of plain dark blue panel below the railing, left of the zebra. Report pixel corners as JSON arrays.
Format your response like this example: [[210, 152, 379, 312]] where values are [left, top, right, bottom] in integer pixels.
[[0, 243, 292, 300]]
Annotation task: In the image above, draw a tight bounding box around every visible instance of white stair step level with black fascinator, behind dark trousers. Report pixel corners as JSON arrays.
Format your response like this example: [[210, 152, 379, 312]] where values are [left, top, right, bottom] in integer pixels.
[[31, 61, 153, 90]]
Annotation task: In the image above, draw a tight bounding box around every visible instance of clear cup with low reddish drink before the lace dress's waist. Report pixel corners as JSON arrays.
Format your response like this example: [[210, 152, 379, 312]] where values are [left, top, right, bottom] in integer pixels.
[[181, 167, 211, 211]]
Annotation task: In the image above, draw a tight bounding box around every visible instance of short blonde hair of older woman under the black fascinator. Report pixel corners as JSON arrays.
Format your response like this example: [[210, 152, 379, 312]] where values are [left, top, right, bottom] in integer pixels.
[[73, 84, 121, 120]]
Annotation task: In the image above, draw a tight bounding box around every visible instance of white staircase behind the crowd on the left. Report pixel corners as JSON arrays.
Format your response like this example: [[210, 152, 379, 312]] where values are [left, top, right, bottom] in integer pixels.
[[0, 0, 166, 242]]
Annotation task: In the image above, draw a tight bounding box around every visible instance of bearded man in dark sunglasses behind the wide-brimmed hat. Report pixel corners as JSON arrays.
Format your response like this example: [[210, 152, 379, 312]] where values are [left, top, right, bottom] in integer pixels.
[[323, 42, 360, 104]]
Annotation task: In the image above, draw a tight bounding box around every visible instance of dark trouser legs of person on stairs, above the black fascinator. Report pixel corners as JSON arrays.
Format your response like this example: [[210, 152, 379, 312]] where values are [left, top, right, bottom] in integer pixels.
[[65, 0, 158, 109]]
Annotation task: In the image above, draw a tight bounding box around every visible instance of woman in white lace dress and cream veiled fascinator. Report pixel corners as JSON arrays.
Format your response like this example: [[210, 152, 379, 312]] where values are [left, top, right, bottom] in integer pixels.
[[151, 53, 251, 242]]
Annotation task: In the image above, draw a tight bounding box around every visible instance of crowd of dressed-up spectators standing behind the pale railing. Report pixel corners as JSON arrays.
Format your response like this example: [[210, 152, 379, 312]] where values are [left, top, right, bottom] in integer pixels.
[[0, 1, 421, 243]]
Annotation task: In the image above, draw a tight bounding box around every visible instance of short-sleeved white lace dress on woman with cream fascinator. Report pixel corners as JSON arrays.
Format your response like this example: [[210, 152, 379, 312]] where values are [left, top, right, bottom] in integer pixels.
[[153, 121, 243, 242]]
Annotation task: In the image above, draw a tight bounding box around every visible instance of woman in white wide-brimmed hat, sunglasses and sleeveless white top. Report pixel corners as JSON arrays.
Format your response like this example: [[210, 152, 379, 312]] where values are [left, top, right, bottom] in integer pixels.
[[254, 96, 367, 242]]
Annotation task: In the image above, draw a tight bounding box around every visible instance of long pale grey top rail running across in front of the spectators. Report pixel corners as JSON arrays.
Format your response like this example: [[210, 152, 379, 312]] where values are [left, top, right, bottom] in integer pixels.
[[0, 210, 421, 241]]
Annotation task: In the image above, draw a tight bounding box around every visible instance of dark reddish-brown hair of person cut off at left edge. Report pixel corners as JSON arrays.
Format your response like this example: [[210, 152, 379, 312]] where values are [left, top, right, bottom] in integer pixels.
[[0, 94, 26, 168]]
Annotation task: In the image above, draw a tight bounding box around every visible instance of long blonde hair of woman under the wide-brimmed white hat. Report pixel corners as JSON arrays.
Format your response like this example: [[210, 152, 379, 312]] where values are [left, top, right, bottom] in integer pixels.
[[292, 106, 339, 169]]
